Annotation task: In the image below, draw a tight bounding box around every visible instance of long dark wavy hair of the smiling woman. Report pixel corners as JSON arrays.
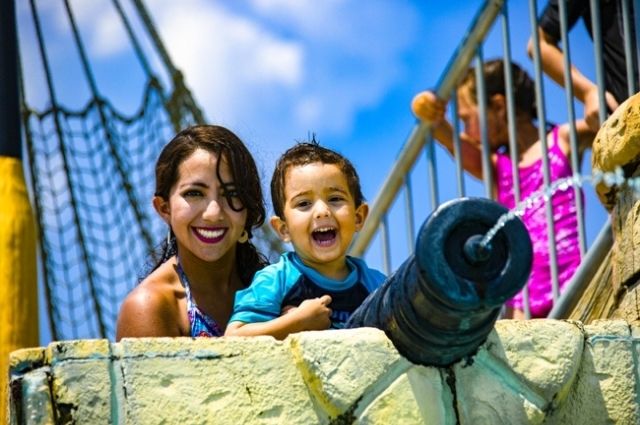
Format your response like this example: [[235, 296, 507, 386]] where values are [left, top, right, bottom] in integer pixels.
[[151, 125, 268, 285]]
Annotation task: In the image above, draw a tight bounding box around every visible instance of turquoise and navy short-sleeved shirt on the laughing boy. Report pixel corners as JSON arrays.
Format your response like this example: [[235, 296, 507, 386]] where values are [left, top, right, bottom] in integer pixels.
[[229, 252, 386, 329]]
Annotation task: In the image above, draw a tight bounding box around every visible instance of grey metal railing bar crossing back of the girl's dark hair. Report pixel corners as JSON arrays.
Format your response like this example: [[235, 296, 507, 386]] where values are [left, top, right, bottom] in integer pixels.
[[502, 3, 531, 319]]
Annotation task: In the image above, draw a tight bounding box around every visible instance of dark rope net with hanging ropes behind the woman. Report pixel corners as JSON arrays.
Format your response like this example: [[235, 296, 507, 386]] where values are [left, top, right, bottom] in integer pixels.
[[22, 0, 279, 340]]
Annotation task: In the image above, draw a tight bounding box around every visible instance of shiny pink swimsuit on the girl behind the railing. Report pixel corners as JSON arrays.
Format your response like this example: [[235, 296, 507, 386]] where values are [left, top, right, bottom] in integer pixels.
[[496, 127, 584, 317]]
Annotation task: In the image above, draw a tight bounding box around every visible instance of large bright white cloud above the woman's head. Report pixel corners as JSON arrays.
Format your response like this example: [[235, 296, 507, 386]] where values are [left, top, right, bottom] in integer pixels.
[[150, 0, 304, 122]]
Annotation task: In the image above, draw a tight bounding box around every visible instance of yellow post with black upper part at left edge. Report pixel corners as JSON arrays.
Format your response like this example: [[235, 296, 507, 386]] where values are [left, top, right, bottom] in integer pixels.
[[0, 0, 38, 422]]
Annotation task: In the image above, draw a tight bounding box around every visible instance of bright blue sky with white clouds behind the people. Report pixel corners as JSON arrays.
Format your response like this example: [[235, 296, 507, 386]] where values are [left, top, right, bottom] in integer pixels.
[[16, 0, 606, 342]]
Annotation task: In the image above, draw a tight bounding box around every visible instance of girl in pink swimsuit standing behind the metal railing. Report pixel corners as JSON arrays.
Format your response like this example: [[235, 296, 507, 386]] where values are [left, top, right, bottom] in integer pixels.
[[411, 59, 594, 318]]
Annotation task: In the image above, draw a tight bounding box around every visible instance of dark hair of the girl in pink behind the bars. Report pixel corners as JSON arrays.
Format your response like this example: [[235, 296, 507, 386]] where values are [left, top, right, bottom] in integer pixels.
[[460, 59, 538, 119]]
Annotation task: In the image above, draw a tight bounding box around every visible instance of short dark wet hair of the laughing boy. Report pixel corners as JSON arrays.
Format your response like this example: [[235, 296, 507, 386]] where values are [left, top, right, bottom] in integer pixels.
[[271, 135, 364, 219]]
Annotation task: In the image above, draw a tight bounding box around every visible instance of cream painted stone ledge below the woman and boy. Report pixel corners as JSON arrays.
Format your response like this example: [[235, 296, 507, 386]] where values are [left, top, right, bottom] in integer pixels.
[[10, 320, 640, 425]]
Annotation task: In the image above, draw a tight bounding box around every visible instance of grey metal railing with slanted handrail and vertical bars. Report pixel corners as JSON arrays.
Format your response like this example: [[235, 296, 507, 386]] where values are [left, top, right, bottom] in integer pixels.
[[350, 0, 639, 318]]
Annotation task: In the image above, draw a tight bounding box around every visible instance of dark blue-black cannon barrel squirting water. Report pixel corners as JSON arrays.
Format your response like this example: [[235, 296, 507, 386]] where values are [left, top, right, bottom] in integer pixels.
[[347, 198, 532, 367]]
